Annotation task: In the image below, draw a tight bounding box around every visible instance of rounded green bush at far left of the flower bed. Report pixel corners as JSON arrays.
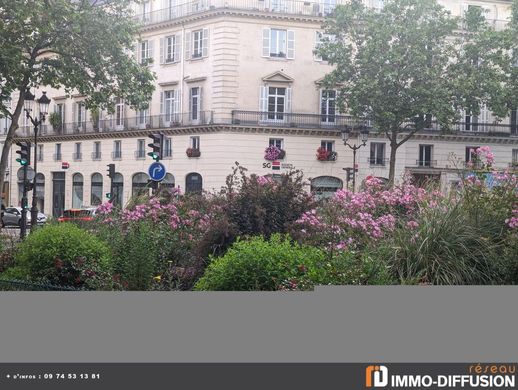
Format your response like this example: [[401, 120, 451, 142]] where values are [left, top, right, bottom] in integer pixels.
[[15, 223, 113, 289]]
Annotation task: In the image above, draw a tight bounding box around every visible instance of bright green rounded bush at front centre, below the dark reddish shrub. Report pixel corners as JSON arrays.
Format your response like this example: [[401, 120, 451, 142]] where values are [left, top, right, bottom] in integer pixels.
[[195, 234, 325, 291]]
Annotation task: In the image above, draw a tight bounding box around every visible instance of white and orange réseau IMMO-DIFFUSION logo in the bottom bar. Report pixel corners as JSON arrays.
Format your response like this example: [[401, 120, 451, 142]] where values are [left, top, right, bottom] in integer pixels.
[[365, 365, 516, 389]]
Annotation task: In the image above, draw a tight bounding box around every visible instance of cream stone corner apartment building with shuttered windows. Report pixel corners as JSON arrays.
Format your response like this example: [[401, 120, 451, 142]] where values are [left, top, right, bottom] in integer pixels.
[[7, 0, 518, 216]]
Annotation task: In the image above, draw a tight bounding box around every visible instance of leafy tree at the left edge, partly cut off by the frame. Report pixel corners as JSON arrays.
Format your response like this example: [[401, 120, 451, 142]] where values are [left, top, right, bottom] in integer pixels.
[[0, 0, 154, 207]]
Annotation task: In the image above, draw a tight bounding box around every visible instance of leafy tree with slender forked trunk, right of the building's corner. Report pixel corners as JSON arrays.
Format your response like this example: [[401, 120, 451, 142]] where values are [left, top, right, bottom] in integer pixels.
[[317, 0, 505, 186]]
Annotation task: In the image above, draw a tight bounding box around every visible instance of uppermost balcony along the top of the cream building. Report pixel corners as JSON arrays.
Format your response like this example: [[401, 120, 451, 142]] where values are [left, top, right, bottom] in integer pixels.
[[135, 0, 342, 26]]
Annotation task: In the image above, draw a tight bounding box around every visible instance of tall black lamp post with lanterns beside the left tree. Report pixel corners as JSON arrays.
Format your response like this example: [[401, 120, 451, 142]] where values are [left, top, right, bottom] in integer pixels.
[[25, 89, 50, 233]]
